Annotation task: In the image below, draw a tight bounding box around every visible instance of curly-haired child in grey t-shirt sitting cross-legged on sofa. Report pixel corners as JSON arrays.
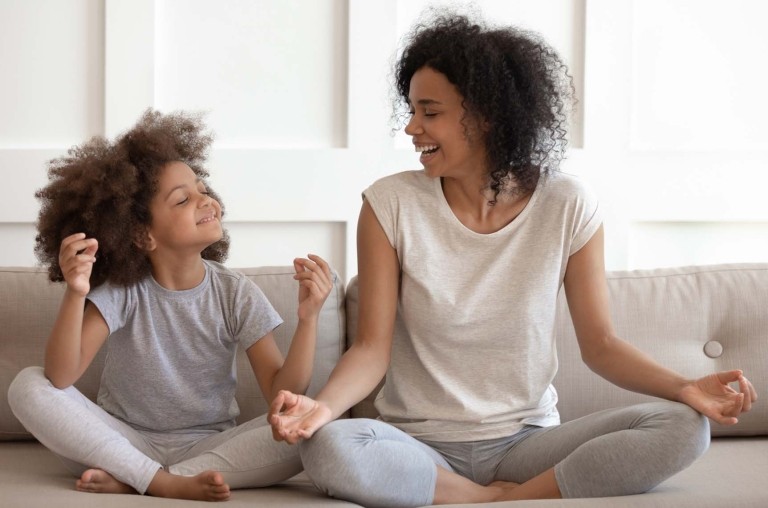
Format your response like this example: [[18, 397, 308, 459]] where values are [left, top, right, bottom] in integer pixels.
[[9, 111, 333, 501]]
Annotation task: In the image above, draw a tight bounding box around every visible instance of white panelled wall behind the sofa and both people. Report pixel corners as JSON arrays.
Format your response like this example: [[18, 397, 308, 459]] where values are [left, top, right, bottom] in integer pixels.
[[0, 0, 768, 278]]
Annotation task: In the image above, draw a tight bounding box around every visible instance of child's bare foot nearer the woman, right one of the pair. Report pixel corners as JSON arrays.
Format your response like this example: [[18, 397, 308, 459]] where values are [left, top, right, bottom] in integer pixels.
[[147, 469, 229, 501]]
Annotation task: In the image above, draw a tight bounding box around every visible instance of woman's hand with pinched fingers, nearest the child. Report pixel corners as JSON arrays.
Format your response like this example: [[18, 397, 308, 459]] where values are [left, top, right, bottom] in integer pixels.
[[268, 390, 332, 444]]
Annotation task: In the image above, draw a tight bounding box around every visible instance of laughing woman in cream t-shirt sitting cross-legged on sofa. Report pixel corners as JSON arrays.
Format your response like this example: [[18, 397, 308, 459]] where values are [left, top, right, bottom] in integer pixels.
[[270, 8, 756, 507]]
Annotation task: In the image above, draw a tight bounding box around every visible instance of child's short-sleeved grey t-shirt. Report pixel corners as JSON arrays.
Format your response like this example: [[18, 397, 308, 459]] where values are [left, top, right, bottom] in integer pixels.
[[88, 261, 282, 432]]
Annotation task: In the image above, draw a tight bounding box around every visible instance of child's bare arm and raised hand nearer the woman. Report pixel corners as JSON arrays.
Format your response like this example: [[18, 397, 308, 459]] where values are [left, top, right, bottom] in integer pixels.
[[247, 254, 333, 401]]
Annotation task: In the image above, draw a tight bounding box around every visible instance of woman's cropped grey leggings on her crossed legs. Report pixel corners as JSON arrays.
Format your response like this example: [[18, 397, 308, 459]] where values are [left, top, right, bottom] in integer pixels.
[[299, 401, 709, 507]]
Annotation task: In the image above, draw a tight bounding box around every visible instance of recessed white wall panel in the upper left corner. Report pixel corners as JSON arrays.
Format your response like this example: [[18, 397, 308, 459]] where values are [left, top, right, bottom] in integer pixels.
[[0, 0, 104, 149]]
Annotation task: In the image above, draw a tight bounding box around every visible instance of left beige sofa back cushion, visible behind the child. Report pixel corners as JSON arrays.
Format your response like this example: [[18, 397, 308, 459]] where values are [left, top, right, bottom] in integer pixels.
[[0, 266, 346, 441]]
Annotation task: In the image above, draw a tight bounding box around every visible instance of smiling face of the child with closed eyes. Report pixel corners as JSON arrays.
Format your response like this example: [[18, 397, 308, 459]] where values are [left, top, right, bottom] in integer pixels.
[[147, 161, 223, 254]]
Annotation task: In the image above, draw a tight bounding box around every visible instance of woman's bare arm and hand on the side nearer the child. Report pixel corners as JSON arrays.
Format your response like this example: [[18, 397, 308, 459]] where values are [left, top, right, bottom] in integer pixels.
[[269, 202, 400, 443]]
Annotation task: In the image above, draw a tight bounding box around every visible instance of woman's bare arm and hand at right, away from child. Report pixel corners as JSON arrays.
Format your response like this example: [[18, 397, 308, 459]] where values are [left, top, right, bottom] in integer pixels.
[[565, 226, 757, 424]]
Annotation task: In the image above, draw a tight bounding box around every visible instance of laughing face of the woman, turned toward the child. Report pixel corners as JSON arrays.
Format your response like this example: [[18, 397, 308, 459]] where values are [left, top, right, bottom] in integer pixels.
[[405, 67, 486, 177]]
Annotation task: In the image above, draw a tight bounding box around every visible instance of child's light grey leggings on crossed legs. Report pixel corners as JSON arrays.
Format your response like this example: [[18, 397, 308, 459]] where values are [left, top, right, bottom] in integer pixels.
[[8, 367, 302, 494]]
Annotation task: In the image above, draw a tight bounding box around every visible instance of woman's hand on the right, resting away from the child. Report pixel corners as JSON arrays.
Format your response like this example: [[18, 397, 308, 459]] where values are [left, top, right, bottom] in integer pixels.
[[680, 370, 757, 425]]
